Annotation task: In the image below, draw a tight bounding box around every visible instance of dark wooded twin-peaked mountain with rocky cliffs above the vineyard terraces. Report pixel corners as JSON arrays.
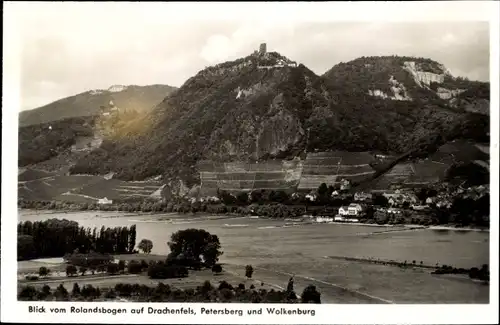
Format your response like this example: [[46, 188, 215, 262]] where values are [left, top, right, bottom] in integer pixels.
[[17, 52, 489, 197]]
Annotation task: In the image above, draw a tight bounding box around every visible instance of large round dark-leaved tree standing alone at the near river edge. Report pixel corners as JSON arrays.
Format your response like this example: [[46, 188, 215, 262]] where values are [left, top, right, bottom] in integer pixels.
[[168, 228, 222, 267]]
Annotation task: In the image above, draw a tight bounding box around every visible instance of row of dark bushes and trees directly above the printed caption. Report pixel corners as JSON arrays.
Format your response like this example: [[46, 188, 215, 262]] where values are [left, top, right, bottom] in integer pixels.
[[18, 281, 321, 304]]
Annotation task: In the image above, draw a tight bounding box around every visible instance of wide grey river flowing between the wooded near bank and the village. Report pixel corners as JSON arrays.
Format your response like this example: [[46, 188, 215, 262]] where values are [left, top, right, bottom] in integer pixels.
[[19, 210, 489, 303]]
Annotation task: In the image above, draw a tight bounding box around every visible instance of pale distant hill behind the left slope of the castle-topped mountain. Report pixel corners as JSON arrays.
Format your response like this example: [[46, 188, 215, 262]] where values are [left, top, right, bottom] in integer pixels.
[[19, 85, 176, 126]]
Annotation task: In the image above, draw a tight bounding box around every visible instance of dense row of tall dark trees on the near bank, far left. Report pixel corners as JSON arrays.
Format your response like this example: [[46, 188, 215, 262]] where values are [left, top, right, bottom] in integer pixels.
[[17, 219, 137, 260]]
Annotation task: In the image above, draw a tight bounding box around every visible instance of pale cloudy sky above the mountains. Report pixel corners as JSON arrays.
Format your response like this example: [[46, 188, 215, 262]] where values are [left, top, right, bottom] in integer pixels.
[[11, 1, 489, 110]]
